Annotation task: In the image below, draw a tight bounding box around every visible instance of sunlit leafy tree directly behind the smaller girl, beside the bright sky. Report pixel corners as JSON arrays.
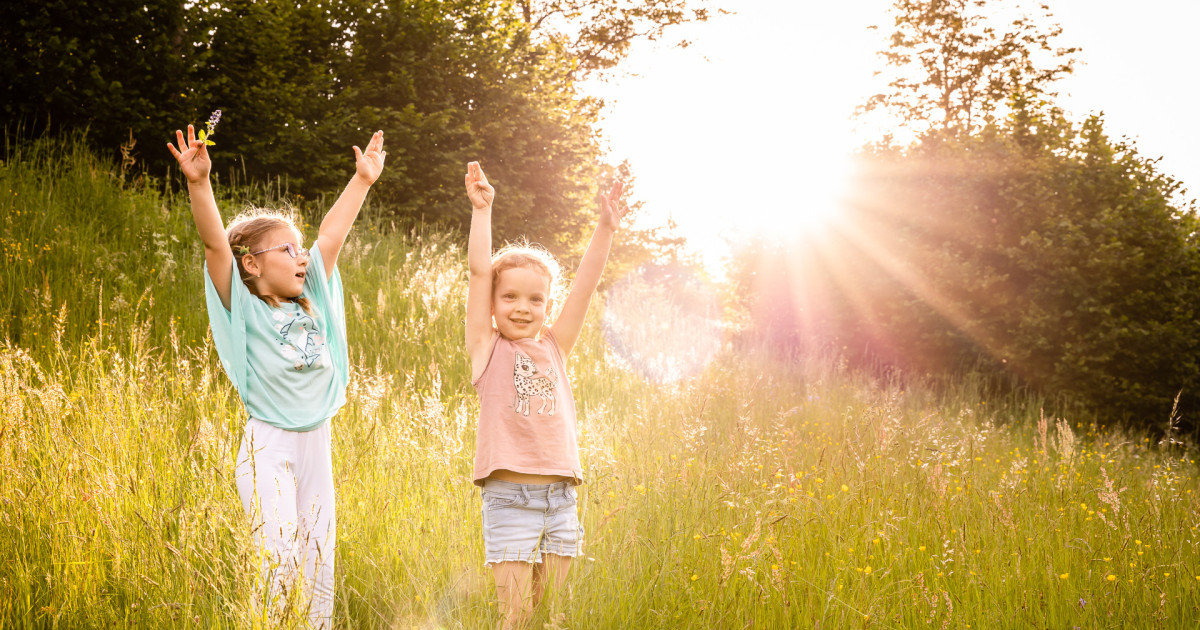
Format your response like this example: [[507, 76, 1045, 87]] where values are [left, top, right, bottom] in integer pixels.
[[326, 0, 600, 253]]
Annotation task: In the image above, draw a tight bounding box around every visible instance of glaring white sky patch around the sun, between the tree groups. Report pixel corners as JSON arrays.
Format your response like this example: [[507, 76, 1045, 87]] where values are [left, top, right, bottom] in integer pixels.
[[571, 0, 888, 266]]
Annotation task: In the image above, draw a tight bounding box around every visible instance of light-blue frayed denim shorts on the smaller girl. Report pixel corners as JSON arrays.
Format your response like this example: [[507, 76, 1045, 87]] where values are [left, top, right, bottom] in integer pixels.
[[484, 479, 583, 564]]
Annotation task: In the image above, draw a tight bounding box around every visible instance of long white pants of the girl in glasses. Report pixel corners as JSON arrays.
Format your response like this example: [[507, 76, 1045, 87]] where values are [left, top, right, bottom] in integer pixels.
[[235, 418, 337, 628]]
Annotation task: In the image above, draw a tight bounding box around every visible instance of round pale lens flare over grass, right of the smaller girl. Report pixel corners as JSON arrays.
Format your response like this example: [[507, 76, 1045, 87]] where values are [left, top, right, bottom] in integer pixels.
[[601, 264, 722, 383]]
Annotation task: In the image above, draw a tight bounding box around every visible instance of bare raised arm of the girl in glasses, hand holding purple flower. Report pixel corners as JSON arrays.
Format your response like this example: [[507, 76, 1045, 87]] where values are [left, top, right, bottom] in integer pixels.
[[167, 125, 233, 310]]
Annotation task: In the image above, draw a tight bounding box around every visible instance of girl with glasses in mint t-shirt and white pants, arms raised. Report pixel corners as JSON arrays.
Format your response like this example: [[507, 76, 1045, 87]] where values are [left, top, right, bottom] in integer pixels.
[[167, 125, 388, 628]]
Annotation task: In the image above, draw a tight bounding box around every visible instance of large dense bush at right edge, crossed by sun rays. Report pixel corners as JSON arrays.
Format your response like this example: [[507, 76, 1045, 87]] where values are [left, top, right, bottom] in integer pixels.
[[834, 110, 1200, 425]]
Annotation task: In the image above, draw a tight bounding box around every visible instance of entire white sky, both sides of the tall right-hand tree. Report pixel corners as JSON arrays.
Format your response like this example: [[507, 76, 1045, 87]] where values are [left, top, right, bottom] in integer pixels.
[[587, 0, 1200, 265]]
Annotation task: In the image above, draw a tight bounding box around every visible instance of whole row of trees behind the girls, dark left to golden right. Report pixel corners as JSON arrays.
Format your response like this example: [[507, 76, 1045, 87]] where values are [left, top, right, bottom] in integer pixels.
[[0, 0, 710, 256]]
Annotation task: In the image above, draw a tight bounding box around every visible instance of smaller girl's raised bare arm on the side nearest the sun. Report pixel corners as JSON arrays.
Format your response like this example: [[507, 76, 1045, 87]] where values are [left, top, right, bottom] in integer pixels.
[[551, 181, 629, 356]]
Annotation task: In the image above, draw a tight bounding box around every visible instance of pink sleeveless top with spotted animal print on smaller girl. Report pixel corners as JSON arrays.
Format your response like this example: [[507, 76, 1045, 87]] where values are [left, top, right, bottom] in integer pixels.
[[474, 329, 583, 485]]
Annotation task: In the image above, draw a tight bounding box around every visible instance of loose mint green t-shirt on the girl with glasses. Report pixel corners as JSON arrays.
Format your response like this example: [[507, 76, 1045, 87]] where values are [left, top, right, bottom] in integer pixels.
[[204, 244, 349, 431]]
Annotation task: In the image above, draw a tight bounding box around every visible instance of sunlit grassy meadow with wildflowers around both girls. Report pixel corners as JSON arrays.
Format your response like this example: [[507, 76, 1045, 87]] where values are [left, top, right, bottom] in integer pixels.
[[0, 136, 1200, 629]]
